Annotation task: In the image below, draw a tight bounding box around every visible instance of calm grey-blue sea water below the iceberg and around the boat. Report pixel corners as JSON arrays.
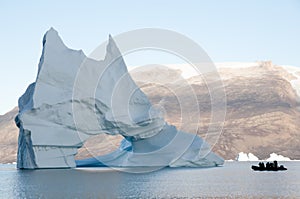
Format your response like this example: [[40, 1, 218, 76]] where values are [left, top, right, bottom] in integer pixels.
[[0, 162, 300, 198]]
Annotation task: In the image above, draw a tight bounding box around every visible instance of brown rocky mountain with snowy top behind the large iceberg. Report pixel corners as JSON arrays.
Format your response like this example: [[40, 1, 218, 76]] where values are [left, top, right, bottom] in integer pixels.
[[0, 62, 300, 163]]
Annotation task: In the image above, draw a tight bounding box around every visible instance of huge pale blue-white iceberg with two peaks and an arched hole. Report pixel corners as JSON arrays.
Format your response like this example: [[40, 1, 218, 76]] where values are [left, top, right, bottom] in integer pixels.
[[15, 28, 224, 169]]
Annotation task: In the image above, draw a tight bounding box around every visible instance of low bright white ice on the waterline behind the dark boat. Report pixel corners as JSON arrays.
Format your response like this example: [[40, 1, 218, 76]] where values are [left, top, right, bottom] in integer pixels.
[[234, 152, 293, 161]]
